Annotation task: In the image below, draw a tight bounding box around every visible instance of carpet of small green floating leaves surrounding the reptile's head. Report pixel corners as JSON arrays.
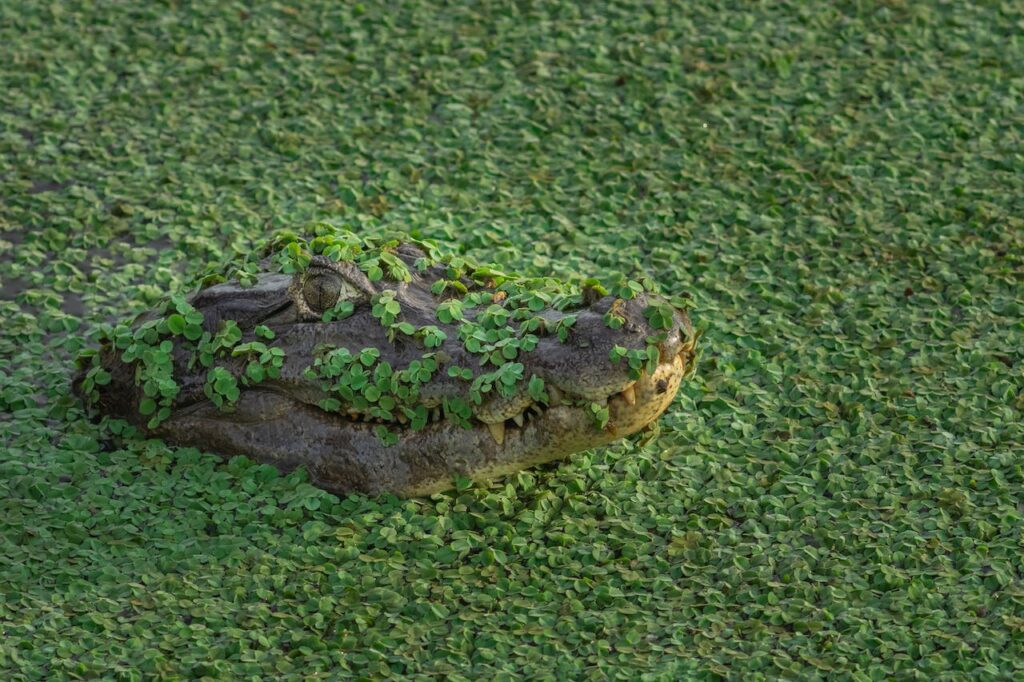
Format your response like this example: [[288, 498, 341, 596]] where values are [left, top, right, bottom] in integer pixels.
[[0, 0, 1024, 681]]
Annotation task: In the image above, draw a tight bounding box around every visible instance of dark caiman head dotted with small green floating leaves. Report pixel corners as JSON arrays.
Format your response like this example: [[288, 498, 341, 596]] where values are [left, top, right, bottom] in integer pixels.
[[73, 223, 697, 497]]
